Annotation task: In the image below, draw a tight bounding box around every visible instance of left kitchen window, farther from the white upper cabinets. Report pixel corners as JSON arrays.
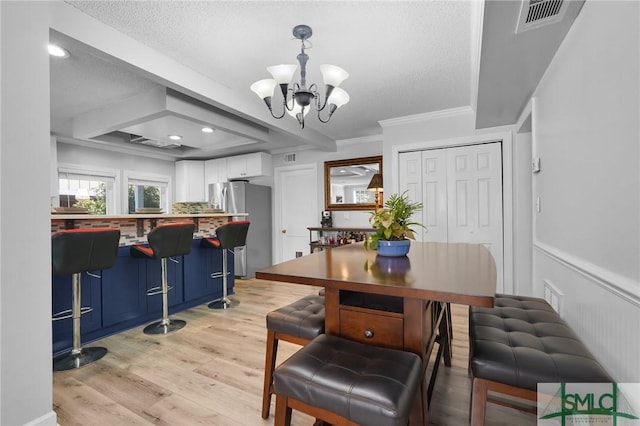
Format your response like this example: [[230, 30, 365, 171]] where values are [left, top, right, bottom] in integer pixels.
[[58, 167, 116, 215]]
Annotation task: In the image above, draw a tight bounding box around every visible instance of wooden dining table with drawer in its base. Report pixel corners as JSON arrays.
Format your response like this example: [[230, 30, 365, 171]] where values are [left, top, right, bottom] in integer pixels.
[[256, 241, 496, 425]]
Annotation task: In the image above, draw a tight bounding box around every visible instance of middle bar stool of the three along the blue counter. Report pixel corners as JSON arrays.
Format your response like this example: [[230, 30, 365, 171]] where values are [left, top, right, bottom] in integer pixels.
[[129, 222, 195, 334]]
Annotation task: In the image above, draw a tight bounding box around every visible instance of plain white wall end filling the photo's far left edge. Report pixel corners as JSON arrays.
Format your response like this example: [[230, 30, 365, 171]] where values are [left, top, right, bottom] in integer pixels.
[[0, 1, 56, 426]]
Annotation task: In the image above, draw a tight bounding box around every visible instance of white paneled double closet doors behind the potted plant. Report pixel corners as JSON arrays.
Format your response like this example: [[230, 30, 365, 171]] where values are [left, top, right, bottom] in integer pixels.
[[398, 142, 504, 289]]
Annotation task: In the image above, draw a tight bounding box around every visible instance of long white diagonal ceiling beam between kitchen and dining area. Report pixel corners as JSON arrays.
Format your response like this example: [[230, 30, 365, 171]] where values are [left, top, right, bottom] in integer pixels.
[[50, 2, 337, 152]]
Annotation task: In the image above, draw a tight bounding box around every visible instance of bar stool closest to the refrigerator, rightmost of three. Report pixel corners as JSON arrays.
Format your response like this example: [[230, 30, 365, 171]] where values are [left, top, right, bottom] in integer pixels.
[[200, 220, 251, 309]]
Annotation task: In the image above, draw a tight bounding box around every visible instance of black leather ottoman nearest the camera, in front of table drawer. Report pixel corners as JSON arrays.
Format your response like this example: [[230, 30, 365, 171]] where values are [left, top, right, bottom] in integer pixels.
[[273, 335, 423, 426]]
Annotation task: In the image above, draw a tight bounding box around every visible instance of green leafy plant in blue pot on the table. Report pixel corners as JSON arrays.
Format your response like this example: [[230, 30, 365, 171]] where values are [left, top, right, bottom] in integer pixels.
[[364, 191, 424, 256]]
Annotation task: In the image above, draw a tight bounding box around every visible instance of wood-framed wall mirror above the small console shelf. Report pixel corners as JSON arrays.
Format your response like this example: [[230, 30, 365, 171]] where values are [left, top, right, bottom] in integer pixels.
[[324, 155, 382, 210]]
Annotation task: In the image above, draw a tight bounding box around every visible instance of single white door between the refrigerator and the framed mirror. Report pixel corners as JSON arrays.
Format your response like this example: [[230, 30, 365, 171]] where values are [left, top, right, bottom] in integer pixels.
[[274, 164, 320, 263]]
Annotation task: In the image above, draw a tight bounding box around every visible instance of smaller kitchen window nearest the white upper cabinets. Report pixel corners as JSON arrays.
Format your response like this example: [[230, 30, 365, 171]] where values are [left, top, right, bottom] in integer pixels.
[[126, 174, 170, 213]]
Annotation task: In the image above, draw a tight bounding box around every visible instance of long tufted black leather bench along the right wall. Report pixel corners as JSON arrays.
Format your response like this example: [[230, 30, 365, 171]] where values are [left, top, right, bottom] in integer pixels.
[[469, 294, 612, 425]]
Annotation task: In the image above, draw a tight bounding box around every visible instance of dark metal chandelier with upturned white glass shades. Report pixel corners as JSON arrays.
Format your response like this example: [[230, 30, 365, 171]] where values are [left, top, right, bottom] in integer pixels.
[[251, 25, 349, 129]]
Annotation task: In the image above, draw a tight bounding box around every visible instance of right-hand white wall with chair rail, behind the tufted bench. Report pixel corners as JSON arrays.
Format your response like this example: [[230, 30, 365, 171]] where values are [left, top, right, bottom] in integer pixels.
[[532, 1, 640, 382]]
